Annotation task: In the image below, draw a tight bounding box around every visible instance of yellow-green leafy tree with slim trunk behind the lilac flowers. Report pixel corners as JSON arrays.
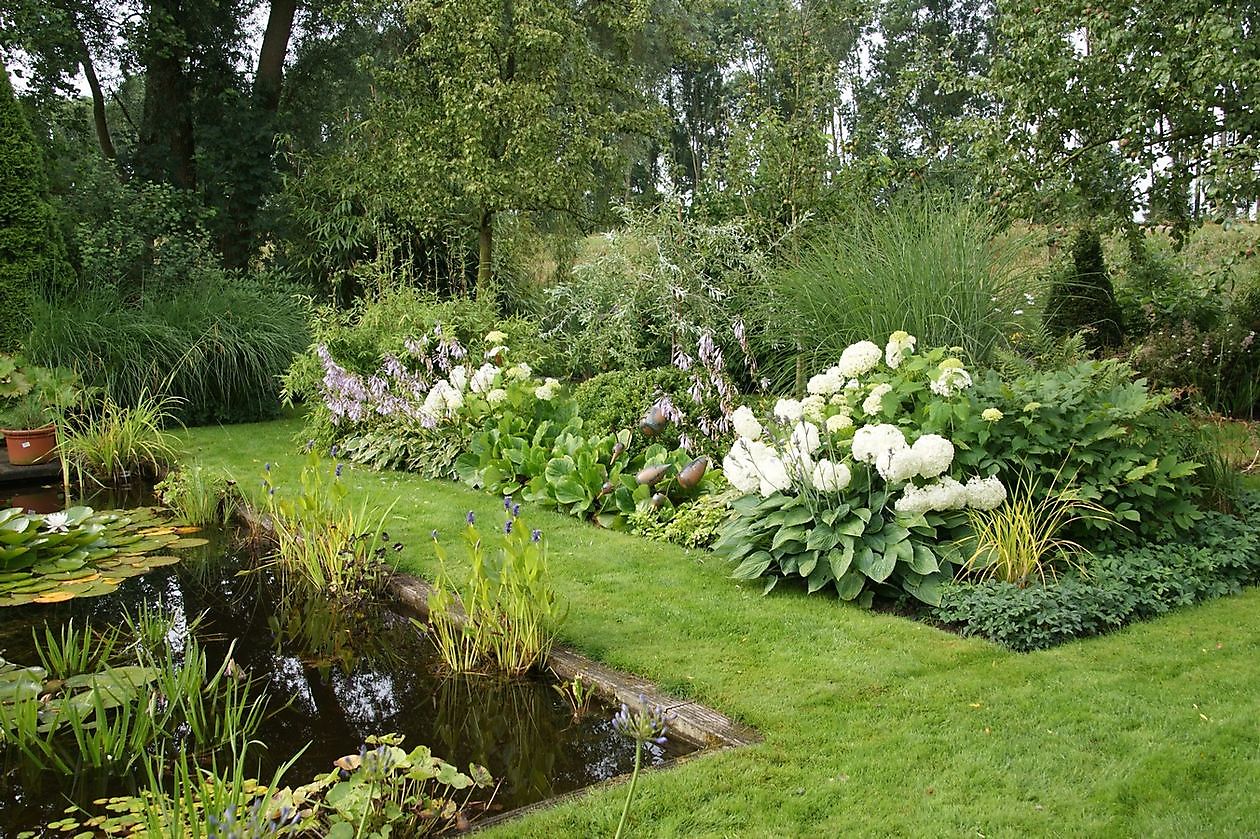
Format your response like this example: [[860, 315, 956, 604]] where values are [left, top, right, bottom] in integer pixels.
[[369, 0, 650, 286]]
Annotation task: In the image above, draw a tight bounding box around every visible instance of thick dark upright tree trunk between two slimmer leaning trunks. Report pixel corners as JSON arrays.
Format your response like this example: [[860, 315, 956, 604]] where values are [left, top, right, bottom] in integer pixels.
[[136, 0, 197, 189]]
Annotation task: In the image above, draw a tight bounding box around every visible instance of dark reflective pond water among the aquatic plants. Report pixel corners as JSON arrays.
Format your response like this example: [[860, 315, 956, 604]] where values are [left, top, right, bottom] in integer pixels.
[[0, 486, 694, 836]]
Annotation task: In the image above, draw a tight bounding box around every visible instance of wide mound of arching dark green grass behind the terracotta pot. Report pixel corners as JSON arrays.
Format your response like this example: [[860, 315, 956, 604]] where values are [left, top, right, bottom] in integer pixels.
[[28, 280, 309, 423]]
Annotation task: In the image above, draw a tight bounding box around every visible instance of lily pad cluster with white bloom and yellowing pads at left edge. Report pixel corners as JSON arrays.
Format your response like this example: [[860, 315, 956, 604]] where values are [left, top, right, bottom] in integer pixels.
[[0, 498, 207, 606]]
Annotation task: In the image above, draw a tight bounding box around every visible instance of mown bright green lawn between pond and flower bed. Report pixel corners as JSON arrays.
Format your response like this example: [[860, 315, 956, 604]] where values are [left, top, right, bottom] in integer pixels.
[[177, 421, 1260, 836]]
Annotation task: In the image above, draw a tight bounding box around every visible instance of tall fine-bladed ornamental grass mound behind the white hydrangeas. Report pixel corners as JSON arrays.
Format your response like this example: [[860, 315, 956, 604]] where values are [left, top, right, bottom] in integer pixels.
[[764, 197, 1029, 382]]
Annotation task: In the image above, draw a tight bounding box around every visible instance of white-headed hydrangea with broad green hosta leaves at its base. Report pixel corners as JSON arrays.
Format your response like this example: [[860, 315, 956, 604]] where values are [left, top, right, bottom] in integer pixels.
[[714, 333, 1005, 603]]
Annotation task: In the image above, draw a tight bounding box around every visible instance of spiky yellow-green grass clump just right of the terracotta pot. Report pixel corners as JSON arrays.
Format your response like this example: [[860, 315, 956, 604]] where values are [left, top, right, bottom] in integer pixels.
[[58, 391, 179, 484]]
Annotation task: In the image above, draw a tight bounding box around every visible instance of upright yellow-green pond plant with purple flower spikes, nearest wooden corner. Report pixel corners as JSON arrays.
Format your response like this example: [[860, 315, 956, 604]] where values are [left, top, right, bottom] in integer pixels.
[[428, 506, 567, 676]]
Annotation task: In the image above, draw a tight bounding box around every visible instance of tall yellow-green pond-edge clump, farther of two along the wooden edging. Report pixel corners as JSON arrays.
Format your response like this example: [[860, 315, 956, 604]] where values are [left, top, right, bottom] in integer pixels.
[[261, 447, 402, 606]]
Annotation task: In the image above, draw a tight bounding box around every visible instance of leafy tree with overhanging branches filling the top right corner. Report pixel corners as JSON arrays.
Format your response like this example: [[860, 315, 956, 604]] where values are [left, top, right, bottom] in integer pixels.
[[987, 0, 1260, 227]]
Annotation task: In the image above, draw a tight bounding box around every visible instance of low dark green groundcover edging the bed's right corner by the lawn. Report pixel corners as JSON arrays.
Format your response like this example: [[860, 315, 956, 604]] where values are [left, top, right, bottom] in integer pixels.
[[931, 496, 1260, 651]]
